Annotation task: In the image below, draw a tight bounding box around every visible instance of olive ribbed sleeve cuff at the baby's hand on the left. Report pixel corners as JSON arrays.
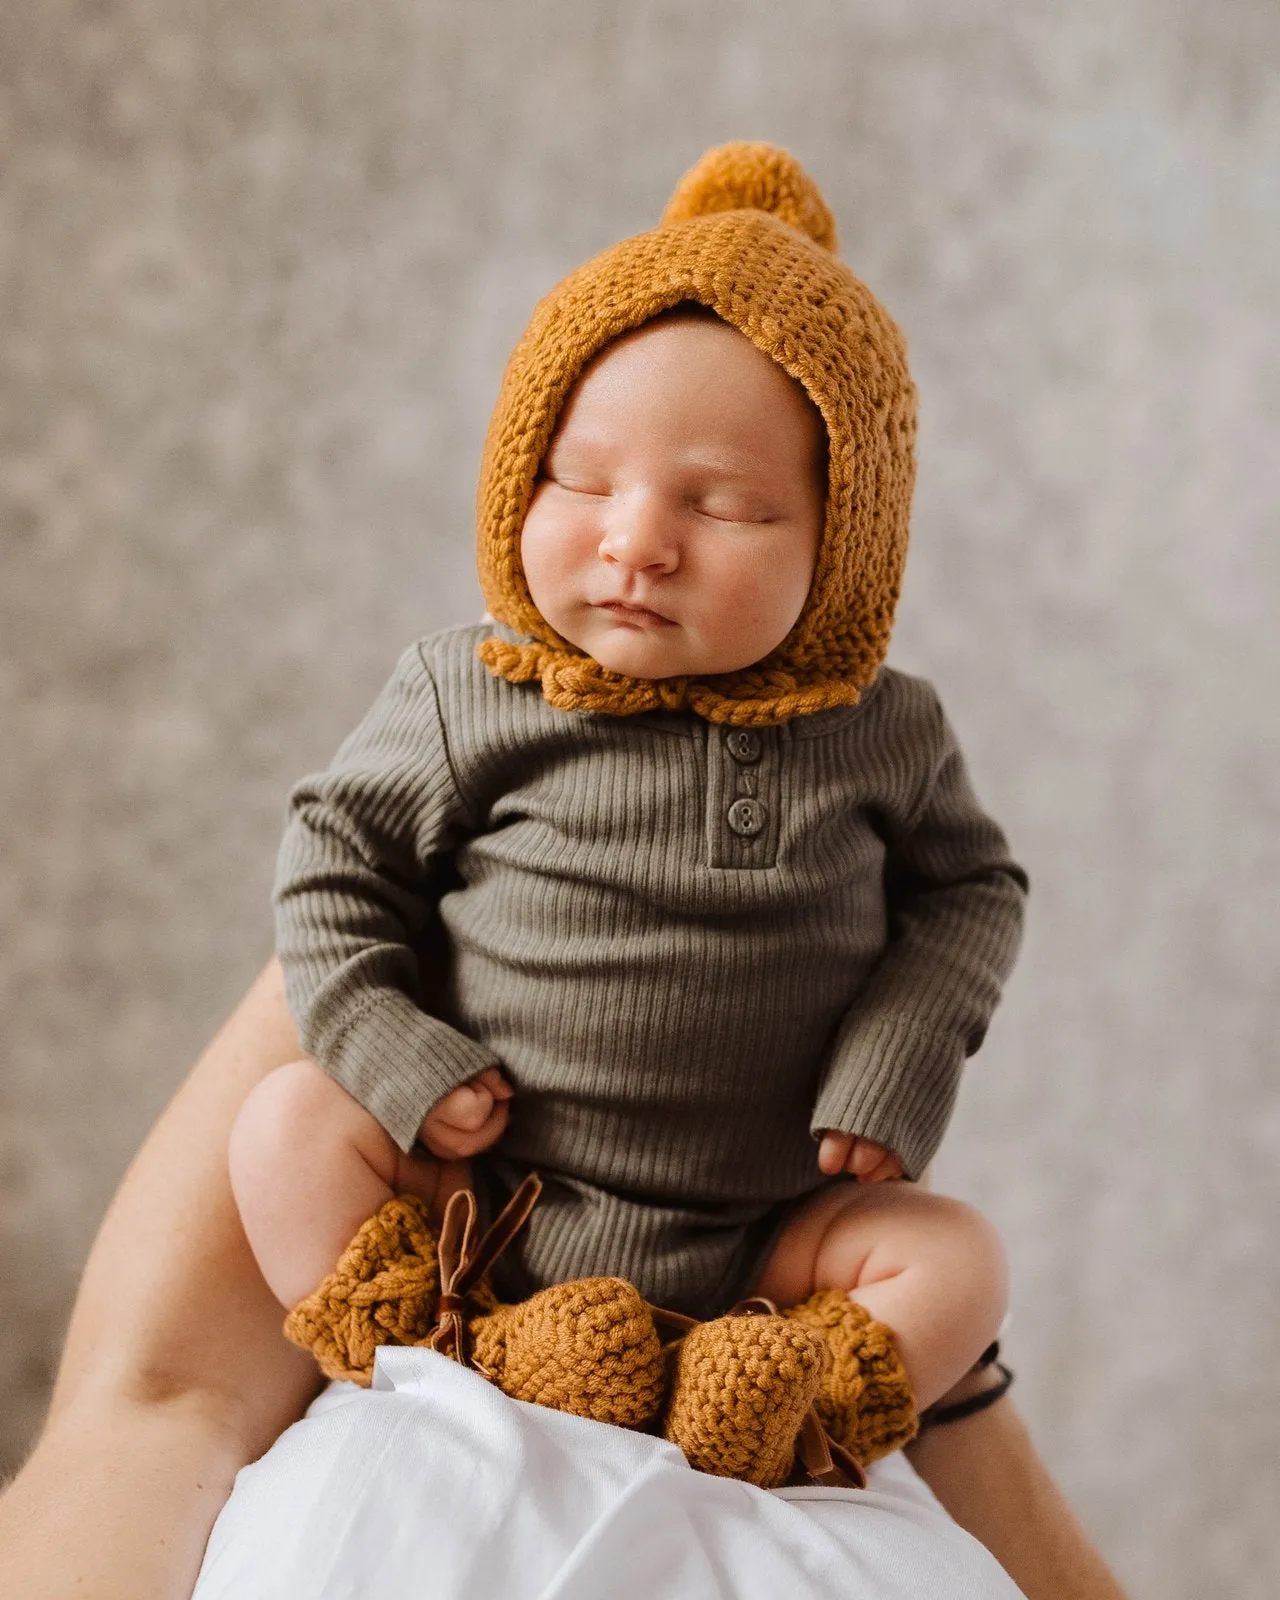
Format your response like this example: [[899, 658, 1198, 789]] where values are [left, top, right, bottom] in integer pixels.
[[315, 992, 501, 1152]]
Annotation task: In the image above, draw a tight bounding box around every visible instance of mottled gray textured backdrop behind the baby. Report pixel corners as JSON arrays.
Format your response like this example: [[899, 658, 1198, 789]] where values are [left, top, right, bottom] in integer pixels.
[[0, 0, 1280, 1600]]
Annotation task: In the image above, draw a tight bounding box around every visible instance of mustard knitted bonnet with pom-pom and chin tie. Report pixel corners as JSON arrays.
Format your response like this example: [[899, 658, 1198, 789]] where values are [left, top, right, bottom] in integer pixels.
[[477, 142, 915, 725]]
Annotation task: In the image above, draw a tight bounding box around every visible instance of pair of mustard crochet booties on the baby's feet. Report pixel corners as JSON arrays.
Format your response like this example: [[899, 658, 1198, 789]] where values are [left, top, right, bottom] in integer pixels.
[[285, 1195, 917, 1488]]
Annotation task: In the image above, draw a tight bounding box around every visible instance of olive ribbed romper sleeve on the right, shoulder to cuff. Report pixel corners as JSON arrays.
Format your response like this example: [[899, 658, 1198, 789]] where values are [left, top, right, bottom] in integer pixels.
[[811, 690, 1027, 1178]]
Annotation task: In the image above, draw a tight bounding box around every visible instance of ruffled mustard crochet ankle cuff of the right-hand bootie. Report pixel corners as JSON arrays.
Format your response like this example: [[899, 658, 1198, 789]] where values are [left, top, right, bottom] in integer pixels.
[[786, 1290, 920, 1467]]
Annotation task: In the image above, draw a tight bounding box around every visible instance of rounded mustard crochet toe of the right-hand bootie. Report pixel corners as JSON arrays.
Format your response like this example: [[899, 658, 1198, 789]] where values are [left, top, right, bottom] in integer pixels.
[[662, 1312, 830, 1488]]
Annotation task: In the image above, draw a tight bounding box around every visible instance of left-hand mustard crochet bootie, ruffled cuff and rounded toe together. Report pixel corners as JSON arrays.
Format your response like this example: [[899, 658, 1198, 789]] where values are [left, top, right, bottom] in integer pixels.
[[285, 1195, 666, 1427]]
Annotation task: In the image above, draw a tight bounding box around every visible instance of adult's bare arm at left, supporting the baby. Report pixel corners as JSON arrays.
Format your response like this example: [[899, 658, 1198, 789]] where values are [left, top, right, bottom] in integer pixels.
[[0, 962, 462, 1600]]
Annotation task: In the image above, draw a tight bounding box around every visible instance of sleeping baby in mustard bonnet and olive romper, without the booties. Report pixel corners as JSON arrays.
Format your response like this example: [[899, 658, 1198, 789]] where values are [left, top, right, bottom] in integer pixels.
[[230, 144, 1026, 1484]]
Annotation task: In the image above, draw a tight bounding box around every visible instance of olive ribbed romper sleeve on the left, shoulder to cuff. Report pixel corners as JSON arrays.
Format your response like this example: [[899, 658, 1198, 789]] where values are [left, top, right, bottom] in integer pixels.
[[274, 645, 498, 1150]]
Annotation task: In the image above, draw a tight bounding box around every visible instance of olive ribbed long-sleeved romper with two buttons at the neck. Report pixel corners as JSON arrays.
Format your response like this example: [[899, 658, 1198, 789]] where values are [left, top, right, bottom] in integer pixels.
[[275, 626, 1026, 1315]]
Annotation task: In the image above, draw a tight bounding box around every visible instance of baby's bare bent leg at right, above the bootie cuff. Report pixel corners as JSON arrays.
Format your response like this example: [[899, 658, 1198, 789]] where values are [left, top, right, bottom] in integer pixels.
[[757, 1182, 1008, 1411]]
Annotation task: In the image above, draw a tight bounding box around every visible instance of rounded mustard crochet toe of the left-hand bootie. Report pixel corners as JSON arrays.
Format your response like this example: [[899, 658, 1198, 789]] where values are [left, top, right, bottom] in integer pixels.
[[467, 1278, 666, 1427]]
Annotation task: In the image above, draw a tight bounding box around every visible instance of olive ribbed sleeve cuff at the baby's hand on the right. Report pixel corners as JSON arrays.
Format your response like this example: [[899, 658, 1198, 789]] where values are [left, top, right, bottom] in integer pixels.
[[810, 1016, 965, 1178]]
